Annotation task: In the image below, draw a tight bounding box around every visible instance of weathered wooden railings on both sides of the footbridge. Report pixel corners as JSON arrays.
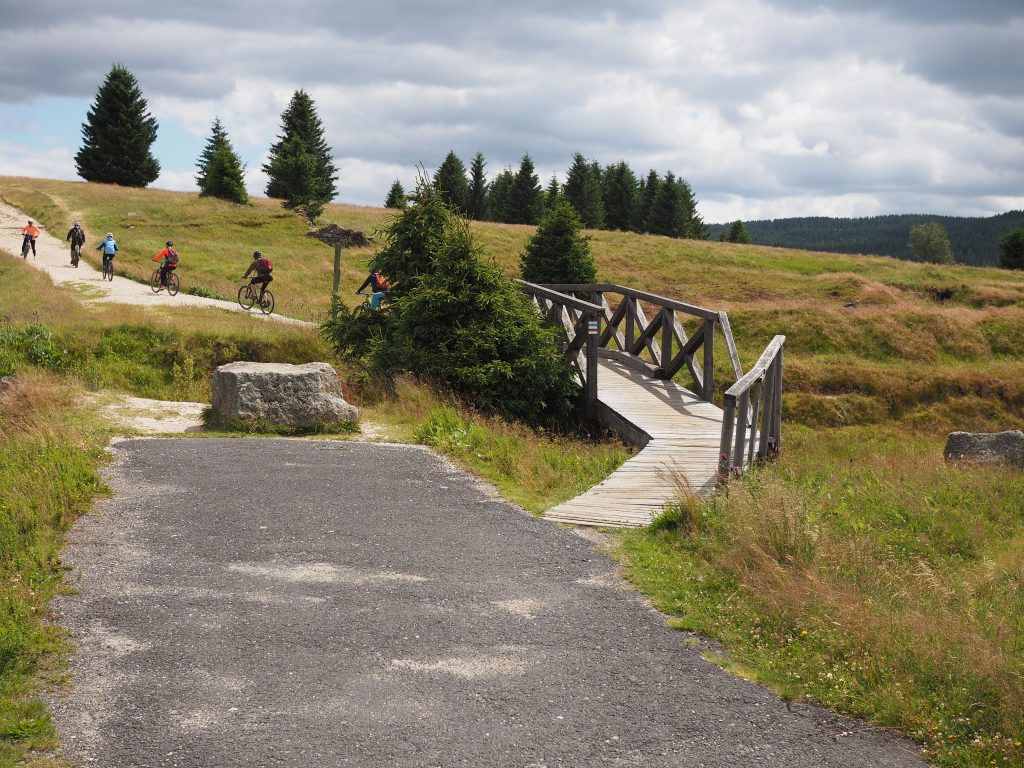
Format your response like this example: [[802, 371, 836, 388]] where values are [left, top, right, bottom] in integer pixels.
[[519, 281, 785, 479]]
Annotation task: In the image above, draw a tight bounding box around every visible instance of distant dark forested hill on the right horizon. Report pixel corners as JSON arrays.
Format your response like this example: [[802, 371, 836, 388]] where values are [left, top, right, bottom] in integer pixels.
[[708, 211, 1024, 266]]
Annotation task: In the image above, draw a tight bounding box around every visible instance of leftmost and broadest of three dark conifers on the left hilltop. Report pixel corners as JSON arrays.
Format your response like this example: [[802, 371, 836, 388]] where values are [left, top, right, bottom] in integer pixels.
[[75, 65, 160, 186]]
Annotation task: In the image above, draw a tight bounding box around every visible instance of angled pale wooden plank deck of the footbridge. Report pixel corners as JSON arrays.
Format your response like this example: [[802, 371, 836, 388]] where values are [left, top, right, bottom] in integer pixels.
[[545, 359, 722, 527]]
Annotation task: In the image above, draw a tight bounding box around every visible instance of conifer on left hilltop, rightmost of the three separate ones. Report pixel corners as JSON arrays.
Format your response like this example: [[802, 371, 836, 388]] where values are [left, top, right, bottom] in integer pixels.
[[263, 89, 338, 219]]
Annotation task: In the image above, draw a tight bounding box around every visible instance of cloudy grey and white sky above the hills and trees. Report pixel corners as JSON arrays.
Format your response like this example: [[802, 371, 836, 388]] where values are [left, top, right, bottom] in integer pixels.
[[0, 0, 1024, 222]]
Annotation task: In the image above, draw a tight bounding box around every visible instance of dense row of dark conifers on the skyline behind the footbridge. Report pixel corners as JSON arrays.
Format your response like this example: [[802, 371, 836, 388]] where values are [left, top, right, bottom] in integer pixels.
[[384, 151, 707, 240]]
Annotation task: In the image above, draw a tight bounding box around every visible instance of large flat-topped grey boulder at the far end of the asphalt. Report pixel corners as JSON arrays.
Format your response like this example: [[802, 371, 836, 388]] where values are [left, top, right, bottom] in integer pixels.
[[213, 362, 358, 429]]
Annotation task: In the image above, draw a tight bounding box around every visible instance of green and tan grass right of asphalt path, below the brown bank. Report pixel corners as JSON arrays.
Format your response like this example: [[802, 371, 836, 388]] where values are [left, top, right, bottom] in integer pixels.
[[623, 428, 1024, 766]]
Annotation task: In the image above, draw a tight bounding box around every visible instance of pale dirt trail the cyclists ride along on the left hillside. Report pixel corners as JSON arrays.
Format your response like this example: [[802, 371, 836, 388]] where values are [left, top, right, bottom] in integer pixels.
[[0, 202, 312, 326]]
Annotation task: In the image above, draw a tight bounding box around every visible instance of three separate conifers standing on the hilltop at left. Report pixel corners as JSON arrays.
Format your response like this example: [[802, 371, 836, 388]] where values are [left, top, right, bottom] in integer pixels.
[[75, 65, 338, 219]]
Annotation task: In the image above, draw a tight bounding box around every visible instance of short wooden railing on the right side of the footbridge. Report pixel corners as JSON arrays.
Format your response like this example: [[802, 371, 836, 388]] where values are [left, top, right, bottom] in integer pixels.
[[718, 336, 785, 481]]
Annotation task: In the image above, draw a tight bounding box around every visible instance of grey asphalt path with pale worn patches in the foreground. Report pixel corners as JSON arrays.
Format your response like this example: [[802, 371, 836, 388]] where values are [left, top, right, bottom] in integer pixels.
[[52, 438, 924, 768]]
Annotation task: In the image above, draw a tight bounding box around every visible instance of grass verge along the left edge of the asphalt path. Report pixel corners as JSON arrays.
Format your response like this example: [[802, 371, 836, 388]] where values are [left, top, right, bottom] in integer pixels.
[[0, 372, 105, 766]]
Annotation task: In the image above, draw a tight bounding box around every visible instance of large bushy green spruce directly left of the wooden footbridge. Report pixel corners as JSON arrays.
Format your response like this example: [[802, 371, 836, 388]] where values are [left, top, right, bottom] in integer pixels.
[[322, 185, 579, 423]]
